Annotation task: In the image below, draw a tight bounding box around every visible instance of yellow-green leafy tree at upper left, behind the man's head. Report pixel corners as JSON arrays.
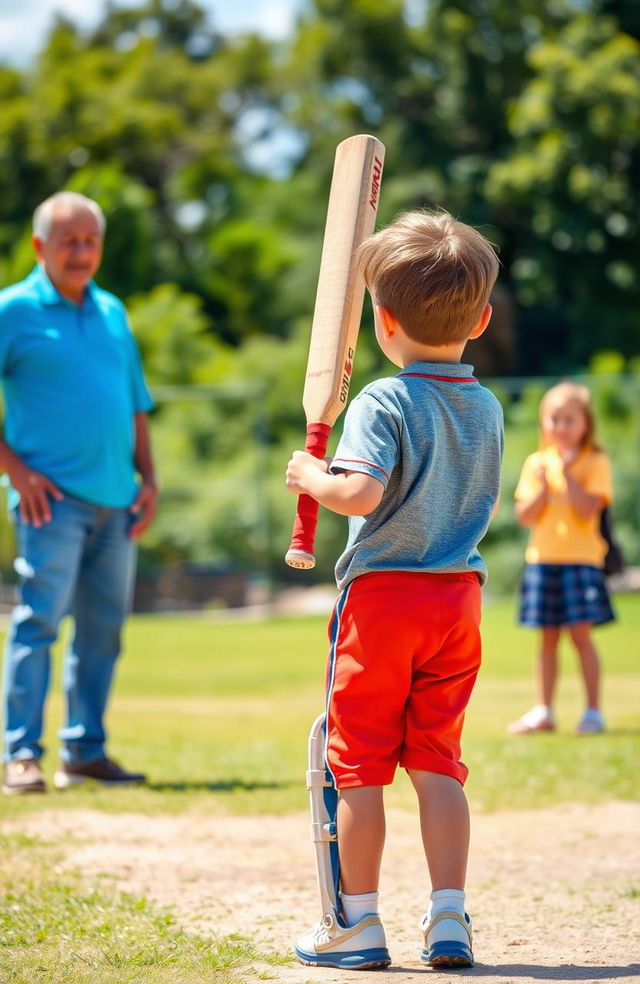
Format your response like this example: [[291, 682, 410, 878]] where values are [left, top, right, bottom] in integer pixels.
[[0, 0, 293, 344]]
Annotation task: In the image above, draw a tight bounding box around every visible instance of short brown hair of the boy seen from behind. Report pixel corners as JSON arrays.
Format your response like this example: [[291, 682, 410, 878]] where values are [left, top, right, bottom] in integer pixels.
[[359, 210, 498, 346]]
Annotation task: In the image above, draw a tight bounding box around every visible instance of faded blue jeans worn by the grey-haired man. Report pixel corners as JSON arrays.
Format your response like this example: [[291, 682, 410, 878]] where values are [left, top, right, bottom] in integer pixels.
[[4, 496, 135, 764]]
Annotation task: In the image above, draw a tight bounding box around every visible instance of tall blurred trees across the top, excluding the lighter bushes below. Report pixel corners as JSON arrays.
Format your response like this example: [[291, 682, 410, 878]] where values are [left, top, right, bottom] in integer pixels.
[[0, 0, 640, 364]]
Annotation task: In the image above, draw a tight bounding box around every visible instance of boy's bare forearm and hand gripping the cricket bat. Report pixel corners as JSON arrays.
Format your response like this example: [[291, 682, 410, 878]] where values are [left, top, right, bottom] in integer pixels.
[[286, 451, 384, 516]]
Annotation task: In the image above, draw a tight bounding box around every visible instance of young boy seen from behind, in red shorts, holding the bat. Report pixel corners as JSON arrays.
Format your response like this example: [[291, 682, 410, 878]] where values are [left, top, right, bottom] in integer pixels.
[[286, 211, 503, 968]]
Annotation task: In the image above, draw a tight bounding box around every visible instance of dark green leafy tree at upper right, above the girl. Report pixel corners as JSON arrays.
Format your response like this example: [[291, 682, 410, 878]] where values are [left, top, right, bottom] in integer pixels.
[[486, 14, 640, 368]]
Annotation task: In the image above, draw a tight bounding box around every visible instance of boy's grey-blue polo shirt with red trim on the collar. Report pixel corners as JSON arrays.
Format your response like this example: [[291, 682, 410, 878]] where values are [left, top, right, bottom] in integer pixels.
[[331, 362, 504, 590]]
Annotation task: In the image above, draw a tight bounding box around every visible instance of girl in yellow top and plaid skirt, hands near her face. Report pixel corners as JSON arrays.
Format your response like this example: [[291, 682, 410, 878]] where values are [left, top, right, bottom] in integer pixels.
[[508, 382, 614, 735]]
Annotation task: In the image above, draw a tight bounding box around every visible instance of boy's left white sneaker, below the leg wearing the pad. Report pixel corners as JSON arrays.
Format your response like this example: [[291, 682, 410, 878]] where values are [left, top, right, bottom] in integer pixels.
[[295, 915, 391, 970]]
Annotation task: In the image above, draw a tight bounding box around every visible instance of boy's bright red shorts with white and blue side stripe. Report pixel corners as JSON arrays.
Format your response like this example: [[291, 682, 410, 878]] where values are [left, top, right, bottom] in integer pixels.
[[326, 571, 481, 789]]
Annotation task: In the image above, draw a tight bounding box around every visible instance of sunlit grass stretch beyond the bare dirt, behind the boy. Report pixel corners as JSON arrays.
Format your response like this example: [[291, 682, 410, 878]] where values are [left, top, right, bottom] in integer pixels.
[[3, 596, 640, 816]]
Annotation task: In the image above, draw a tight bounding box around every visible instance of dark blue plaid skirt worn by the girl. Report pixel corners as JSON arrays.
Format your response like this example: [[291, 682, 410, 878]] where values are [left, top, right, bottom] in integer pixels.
[[518, 564, 615, 628]]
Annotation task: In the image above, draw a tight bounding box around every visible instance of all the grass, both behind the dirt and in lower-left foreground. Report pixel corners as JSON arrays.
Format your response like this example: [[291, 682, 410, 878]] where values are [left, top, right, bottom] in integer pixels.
[[0, 597, 640, 984]]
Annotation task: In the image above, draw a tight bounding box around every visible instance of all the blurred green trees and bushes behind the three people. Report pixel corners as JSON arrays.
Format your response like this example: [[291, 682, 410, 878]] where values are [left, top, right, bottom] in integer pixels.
[[0, 0, 640, 587]]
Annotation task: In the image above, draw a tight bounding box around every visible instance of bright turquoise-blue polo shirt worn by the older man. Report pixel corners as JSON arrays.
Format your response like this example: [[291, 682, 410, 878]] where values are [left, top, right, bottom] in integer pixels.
[[0, 267, 152, 508]]
